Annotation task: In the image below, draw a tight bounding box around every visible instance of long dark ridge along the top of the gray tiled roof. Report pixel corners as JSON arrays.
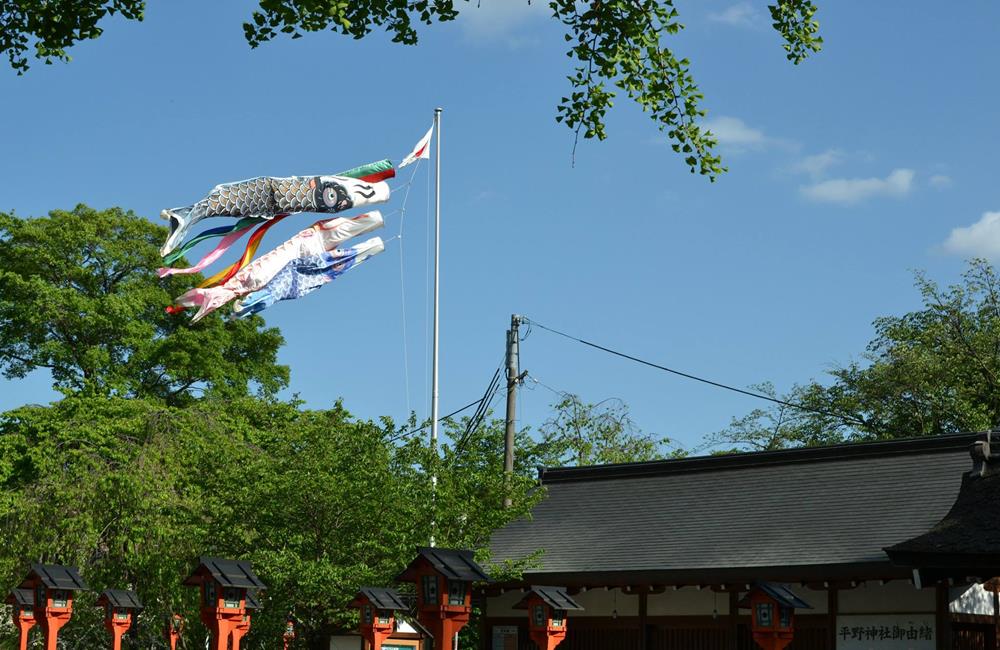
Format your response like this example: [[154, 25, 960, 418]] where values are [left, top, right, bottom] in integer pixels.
[[539, 432, 984, 483]]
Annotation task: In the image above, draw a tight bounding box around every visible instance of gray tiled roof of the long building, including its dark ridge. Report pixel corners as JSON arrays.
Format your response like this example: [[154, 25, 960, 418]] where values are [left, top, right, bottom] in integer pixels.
[[490, 434, 975, 577]]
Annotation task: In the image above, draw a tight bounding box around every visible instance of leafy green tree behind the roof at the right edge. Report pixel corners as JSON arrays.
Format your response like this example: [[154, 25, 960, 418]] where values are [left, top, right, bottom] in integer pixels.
[[708, 259, 1000, 449]]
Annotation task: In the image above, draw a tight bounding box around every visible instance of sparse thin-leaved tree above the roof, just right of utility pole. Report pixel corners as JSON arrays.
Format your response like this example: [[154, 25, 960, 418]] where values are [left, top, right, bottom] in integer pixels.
[[535, 393, 683, 466]]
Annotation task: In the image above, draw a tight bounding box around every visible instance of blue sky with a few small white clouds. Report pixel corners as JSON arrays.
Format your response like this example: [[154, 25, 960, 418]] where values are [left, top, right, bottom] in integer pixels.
[[0, 0, 1000, 446]]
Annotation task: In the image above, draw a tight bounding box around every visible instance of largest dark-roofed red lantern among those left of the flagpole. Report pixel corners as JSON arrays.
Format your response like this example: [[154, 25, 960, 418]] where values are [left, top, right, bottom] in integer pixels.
[[184, 557, 266, 650]]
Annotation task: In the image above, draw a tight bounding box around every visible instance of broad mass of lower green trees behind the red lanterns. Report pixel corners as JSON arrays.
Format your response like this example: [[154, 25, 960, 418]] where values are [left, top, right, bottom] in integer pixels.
[[0, 395, 541, 649]]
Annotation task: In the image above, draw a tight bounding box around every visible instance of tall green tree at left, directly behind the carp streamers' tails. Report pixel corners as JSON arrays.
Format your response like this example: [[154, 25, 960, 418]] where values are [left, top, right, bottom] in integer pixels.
[[0, 205, 288, 404]]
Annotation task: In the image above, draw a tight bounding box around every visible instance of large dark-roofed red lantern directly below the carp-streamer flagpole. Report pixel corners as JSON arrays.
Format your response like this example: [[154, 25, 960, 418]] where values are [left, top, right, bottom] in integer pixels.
[[396, 547, 489, 650]]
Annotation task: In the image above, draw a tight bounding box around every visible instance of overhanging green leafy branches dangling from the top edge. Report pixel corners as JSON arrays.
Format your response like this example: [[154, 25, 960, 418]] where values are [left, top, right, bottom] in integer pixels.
[[0, 0, 823, 179]]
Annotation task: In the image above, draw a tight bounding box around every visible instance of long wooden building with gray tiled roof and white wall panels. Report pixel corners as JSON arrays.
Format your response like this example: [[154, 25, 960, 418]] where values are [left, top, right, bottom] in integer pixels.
[[482, 434, 1000, 650]]
